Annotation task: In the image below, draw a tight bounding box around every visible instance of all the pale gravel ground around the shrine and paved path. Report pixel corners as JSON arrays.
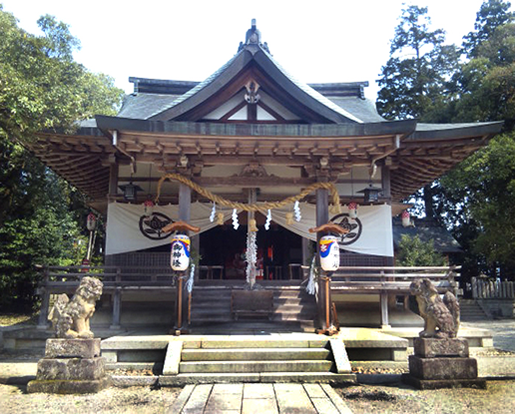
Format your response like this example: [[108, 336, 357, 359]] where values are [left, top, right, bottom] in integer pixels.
[[0, 318, 515, 414]]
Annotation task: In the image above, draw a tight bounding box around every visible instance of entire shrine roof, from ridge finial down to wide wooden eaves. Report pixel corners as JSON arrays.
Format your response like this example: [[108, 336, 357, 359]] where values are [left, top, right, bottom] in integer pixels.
[[26, 20, 502, 209]]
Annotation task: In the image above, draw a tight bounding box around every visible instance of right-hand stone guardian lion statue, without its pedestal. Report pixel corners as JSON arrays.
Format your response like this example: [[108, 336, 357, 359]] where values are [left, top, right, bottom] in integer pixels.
[[410, 279, 460, 338]]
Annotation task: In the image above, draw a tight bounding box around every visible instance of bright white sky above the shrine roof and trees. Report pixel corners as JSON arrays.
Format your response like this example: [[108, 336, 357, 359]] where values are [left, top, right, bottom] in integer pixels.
[[0, 0, 500, 99]]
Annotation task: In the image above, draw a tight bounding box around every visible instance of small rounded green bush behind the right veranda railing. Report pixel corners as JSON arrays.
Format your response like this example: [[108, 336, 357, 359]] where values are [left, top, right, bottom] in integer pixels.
[[396, 234, 446, 266]]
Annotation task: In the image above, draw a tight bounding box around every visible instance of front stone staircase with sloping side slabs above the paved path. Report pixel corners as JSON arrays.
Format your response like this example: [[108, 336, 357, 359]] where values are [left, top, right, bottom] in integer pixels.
[[160, 335, 355, 385]]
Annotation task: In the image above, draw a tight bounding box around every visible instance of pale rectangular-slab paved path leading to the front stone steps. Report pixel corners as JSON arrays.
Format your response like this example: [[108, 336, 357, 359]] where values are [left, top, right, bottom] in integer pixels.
[[170, 384, 352, 414]]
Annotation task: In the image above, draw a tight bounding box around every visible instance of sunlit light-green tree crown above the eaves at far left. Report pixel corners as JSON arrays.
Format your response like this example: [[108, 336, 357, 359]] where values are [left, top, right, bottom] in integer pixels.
[[0, 5, 123, 141]]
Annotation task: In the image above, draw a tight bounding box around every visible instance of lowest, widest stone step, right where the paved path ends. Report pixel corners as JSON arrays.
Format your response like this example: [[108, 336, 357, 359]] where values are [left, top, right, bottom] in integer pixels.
[[159, 372, 356, 387]]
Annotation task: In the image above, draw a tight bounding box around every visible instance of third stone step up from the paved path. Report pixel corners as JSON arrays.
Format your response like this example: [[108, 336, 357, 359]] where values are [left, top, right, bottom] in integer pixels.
[[182, 348, 331, 362]]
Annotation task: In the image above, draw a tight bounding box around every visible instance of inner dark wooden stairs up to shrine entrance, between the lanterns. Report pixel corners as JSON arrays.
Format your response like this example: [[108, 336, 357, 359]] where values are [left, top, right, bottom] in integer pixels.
[[191, 286, 317, 332]]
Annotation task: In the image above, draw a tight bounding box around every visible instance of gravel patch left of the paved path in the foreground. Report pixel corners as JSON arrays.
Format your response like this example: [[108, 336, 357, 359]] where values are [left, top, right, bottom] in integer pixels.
[[0, 385, 181, 414]]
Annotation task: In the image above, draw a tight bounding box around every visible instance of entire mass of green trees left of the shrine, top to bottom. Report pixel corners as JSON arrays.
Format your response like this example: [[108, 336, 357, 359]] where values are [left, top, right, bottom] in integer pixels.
[[0, 5, 122, 310]]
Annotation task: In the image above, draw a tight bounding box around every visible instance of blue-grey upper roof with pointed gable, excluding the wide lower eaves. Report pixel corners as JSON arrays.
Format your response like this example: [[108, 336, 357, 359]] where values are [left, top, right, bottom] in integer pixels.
[[119, 23, 370, 124]]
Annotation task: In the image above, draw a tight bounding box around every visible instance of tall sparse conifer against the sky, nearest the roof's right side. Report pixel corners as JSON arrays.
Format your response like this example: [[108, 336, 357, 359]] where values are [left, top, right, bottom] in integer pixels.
[[377, 6, 459, 121]]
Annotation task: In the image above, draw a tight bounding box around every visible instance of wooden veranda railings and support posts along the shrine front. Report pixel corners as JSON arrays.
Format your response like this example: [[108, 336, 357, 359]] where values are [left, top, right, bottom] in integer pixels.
[[38, 266, 460, 334]]
